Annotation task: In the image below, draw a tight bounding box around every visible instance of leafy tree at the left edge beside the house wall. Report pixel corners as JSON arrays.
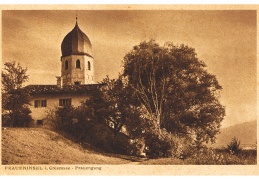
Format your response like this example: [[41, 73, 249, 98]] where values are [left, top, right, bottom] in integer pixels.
[[2, 61, 31, 126]]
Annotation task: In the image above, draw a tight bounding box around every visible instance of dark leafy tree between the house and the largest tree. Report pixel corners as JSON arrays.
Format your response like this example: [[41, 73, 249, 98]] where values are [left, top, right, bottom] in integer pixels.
[[83, 76, 139, 150]]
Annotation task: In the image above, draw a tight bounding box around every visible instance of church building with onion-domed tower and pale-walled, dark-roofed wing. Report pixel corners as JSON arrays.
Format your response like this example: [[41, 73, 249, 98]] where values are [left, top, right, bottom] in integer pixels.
[[25, 19, 100, 126]]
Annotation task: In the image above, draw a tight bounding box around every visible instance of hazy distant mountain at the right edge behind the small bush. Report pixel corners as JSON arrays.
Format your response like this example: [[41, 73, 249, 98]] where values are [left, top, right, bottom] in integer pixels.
[[212, 121, 257, 148]]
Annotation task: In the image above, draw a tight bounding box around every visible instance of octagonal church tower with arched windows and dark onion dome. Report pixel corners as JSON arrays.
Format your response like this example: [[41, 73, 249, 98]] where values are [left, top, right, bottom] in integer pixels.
[[60, 18, 94, 86]]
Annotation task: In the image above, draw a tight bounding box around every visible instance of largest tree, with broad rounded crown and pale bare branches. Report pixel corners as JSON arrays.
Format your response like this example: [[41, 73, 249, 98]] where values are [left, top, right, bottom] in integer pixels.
[[123, 40, 225, 144]]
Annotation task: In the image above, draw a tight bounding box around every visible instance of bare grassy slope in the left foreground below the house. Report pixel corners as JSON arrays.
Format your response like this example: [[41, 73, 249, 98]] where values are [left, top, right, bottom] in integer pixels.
[[2, 128, 130, 164]]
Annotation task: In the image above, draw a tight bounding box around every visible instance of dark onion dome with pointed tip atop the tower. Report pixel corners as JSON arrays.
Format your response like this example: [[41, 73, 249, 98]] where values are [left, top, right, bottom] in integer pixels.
[[61, 21, 92, 57]]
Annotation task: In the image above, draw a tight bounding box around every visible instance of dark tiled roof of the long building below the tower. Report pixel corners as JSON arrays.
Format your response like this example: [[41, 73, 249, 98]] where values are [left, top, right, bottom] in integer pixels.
[[24, 84, 102, 94]]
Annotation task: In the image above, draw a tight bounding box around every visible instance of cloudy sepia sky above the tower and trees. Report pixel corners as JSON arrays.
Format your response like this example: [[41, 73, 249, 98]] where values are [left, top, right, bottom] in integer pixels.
[[2, 10, 257, 127]]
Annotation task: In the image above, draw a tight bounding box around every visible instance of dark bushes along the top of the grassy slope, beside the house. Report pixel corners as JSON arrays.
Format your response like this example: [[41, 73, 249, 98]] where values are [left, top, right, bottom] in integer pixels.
[[52, 104, 134, 154]]
